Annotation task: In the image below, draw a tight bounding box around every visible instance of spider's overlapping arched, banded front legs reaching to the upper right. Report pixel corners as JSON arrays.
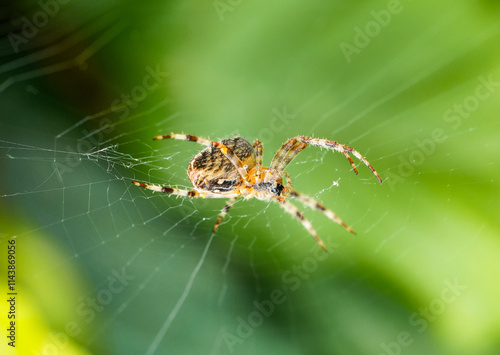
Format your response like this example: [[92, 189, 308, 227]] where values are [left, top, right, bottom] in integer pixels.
[[270, 136, 382, 183]]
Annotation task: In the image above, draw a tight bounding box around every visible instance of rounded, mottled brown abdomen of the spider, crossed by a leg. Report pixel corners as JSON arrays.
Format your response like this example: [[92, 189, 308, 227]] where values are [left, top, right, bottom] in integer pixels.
[[188, 137, 256, 192]]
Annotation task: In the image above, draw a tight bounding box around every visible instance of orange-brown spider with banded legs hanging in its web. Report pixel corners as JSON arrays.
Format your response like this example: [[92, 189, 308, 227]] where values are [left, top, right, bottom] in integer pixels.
[[133, 133, 382, 250]]
